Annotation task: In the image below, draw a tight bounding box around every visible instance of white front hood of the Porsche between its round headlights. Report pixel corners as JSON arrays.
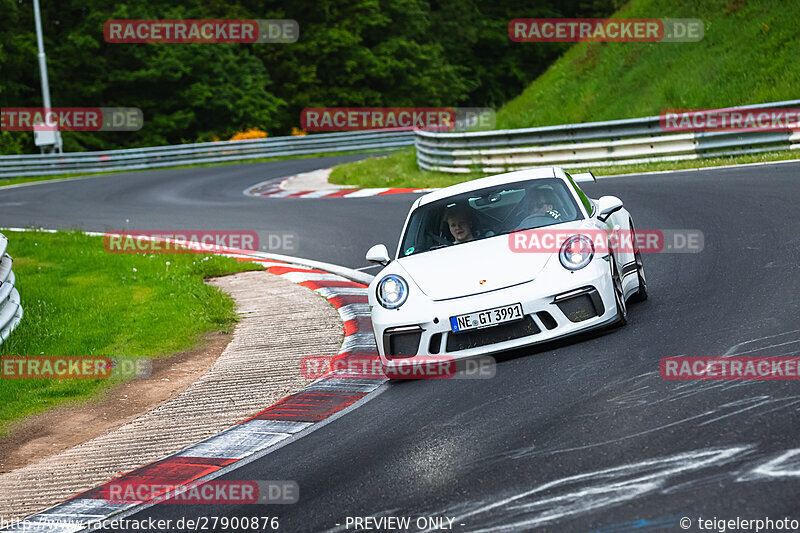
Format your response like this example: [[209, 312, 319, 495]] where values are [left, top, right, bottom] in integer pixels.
[[397, 235, 558, 300]]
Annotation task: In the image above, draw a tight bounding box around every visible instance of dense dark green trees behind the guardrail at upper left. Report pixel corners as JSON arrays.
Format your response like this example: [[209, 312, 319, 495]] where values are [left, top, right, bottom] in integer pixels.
[[0, 0, 620, 153]]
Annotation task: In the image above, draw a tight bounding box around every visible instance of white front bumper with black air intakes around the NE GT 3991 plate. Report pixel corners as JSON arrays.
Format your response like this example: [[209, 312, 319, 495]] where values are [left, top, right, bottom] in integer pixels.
[[371, 256, 617, 368]]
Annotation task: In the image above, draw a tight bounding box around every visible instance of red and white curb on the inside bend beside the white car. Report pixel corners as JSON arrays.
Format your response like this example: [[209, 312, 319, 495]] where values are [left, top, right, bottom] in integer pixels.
[[2, 252, 387, 533]]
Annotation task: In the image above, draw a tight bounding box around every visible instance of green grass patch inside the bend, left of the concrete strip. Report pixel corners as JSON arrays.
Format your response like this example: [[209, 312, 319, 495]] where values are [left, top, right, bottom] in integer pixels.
[[0, 230, 261, 435]]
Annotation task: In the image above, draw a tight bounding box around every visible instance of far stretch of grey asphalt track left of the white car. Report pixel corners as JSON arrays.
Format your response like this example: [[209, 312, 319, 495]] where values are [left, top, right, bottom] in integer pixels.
[[0, 155, 412, 266]]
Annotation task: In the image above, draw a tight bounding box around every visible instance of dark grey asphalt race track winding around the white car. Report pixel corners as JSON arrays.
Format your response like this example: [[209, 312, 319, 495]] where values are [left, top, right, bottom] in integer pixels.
[[0, 158, 800, 532]]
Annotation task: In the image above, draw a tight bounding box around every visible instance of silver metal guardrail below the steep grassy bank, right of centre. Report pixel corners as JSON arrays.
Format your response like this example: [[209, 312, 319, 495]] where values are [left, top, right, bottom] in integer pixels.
[[415, 100, 800, 173]]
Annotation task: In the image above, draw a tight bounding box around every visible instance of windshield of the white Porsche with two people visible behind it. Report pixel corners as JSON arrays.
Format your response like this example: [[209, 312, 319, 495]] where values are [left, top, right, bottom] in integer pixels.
[[399, 178, 583, 257]]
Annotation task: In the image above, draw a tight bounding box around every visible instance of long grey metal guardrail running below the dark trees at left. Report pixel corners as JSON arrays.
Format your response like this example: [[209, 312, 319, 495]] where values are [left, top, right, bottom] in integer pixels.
[[0, 131, 414, 178]]
